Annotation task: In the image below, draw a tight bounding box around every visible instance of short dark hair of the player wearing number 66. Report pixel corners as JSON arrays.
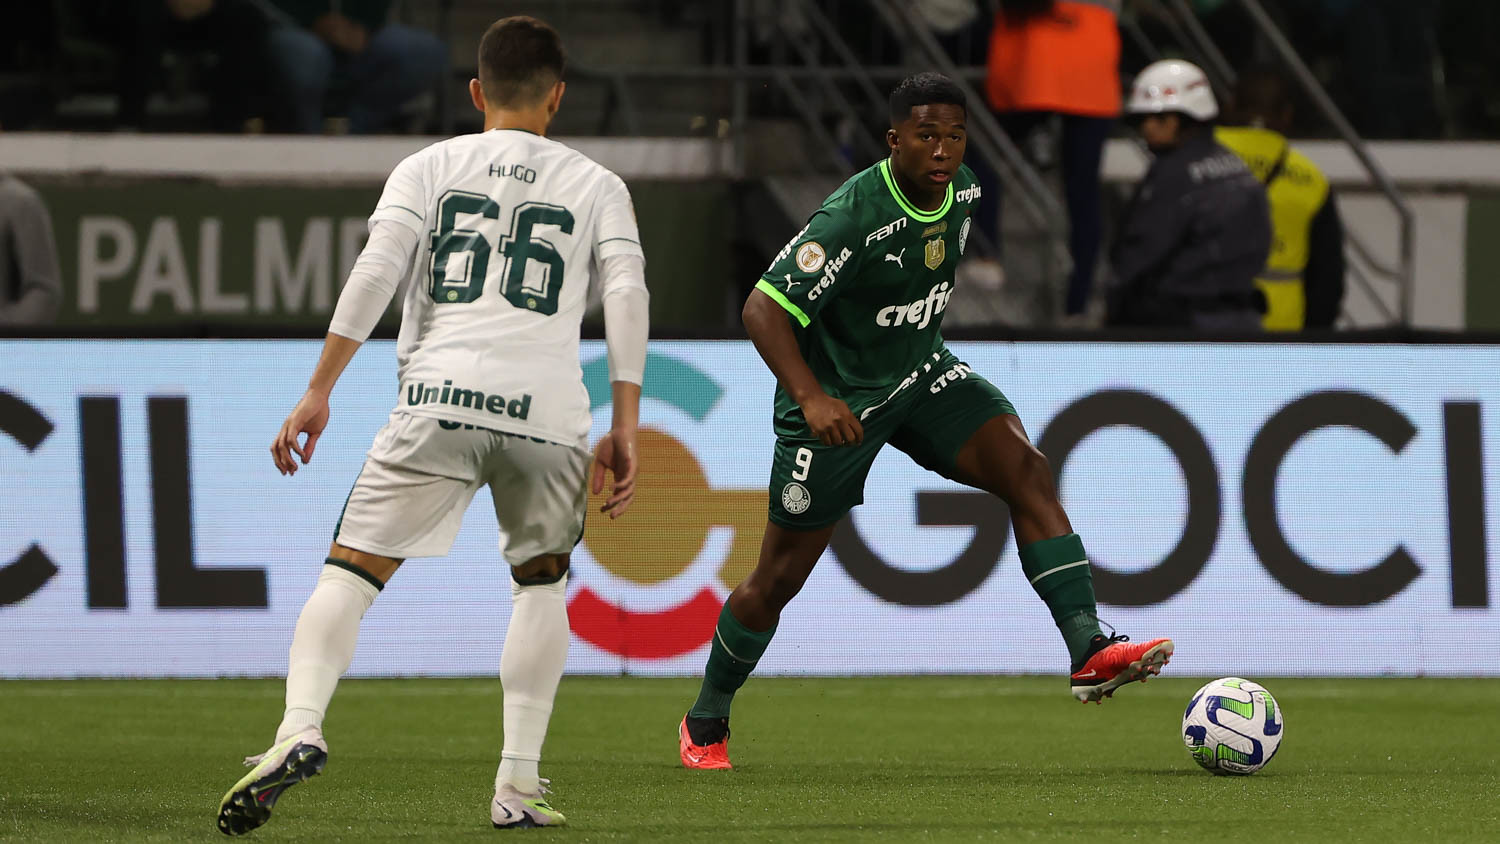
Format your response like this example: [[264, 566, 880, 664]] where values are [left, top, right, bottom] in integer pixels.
[[479, 15, 567, 108]]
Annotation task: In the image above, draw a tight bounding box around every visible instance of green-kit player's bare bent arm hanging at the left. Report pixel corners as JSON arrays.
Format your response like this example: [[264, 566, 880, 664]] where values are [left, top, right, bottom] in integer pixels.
[[741, 289, 864, 445]]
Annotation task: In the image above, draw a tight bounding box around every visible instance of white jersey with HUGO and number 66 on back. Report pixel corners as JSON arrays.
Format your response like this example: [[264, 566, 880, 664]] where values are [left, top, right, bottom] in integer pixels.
[[371, 129, 642, 445]]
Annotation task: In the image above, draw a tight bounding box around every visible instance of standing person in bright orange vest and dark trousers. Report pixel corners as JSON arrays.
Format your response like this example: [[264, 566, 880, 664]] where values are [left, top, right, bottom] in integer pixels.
[[977, 0, 1121, 316]]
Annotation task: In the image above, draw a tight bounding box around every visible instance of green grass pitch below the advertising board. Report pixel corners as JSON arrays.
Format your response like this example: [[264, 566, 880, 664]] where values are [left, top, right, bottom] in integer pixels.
[[0, 669, 1500, 844]]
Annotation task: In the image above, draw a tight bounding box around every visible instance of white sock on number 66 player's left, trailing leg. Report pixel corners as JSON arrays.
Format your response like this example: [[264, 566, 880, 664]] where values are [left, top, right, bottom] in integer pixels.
[[276, 565, 380, 742]]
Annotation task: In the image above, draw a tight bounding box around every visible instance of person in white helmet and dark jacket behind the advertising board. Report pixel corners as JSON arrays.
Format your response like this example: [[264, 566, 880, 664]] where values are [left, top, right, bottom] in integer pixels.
[[1110, 60, 1271, 331]]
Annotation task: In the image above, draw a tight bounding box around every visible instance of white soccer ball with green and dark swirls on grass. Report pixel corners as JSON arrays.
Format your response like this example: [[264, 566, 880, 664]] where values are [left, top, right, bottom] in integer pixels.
[[1182, 678, 1283, 774]]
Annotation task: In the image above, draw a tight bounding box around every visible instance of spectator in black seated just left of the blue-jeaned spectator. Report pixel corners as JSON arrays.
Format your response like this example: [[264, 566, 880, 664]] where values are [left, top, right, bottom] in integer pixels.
[[117, 0, 269, 132]]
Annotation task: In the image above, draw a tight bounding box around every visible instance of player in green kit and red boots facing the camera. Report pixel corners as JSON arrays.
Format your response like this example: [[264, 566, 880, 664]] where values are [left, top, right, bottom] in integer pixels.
[[678, 73, 1172, 769]]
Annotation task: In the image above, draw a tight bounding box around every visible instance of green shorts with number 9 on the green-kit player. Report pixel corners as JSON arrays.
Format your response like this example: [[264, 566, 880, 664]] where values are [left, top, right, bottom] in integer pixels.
[[770, 349, 1016, 531]]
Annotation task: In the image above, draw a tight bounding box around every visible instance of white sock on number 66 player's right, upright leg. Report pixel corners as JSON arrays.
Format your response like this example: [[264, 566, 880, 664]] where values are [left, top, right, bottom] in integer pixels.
[[495, 574, 569, 795]]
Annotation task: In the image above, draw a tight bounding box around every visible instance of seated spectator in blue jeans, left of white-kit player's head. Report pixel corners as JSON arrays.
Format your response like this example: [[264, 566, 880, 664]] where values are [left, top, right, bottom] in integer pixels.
[[270, 0, 447, 135]]
